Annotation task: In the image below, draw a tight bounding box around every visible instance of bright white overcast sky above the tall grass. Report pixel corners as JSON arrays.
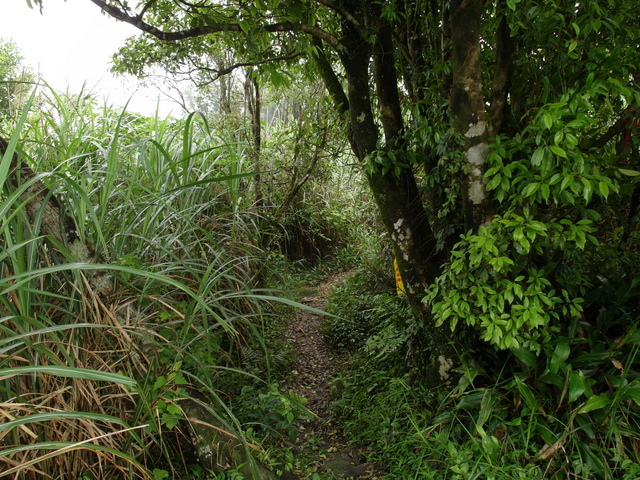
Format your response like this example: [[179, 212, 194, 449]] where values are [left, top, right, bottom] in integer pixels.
[[0, 0, 180, 115]]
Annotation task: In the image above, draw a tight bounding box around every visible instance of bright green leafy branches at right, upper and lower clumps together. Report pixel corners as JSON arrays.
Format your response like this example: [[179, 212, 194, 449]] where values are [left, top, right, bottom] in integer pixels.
[[456, 82, 635, 352]]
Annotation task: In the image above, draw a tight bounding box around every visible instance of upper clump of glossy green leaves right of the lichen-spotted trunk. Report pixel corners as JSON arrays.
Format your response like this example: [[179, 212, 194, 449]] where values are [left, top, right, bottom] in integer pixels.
[[486, 95, 618, 208]]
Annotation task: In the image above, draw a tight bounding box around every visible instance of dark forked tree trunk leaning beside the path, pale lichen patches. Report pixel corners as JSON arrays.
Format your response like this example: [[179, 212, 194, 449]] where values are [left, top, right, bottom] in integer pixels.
[[323, 4, 457, 387]]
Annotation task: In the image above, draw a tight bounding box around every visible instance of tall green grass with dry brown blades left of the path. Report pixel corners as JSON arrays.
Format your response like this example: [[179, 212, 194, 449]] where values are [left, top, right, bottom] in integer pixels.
[[0, 90, 278, 478]]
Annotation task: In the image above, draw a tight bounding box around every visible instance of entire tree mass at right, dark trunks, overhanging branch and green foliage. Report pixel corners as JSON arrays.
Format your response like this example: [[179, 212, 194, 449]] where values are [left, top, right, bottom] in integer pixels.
[[28, 0, 640, 382]]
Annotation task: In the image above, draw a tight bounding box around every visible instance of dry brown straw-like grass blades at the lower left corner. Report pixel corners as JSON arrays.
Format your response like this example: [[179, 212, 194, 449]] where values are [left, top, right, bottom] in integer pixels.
[[0, 283, 161, 480]]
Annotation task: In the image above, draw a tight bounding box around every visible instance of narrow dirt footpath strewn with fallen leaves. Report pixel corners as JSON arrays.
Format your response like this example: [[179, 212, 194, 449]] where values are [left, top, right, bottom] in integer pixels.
[[284, 274, 384, 480]]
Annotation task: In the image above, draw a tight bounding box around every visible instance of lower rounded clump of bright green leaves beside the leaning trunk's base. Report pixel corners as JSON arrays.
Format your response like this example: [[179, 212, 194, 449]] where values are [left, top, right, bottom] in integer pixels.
[[425, 209, 596, 350]]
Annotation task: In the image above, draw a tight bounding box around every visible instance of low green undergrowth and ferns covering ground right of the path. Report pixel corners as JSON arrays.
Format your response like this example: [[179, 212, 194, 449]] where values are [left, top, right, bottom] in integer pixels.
[[326, 260, 640, 480]]
